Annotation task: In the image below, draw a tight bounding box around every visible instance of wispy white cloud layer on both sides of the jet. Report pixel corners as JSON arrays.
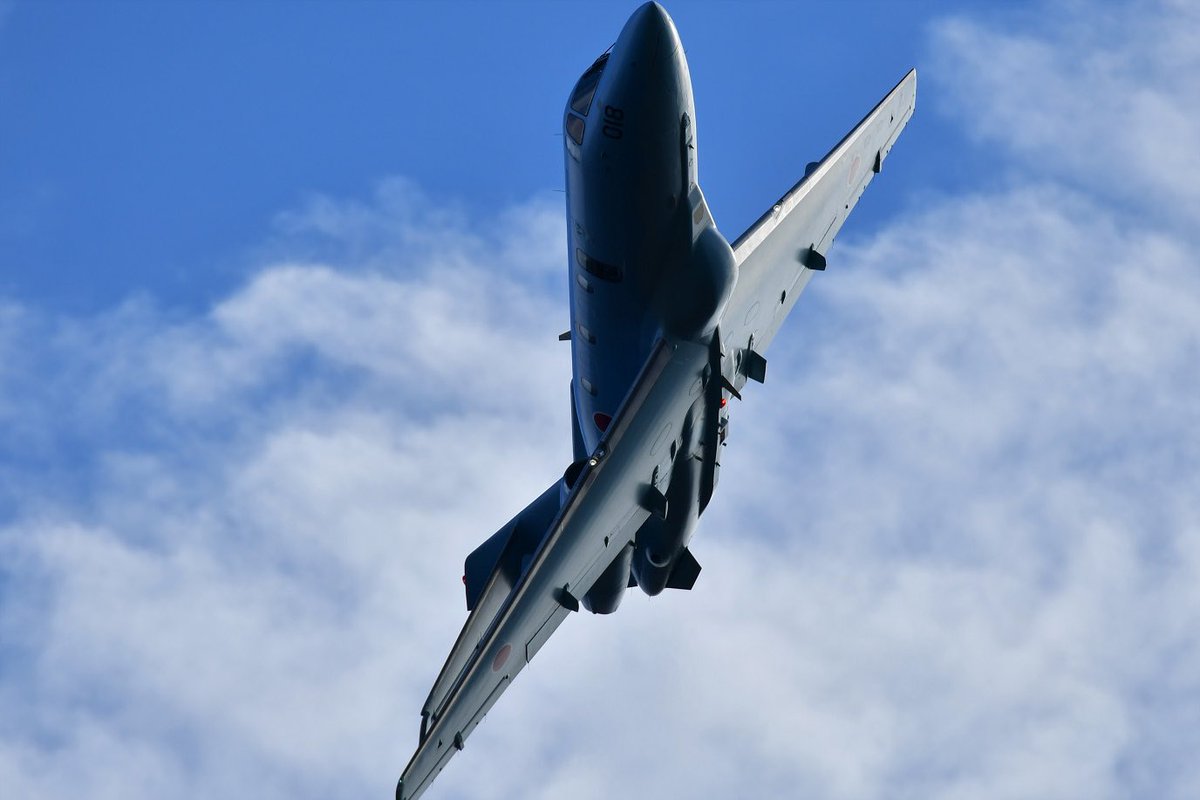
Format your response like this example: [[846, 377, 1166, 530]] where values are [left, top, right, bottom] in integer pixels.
[[0, 5, 1200, 799]]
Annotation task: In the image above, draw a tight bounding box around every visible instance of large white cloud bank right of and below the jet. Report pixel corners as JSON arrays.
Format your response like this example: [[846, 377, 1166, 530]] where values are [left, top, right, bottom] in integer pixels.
[[442, 170, 1200, 798]]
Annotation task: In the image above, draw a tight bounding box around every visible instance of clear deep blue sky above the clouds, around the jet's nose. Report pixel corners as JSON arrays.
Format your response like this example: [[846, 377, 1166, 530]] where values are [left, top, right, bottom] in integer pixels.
[[7, 1, 971, 311]]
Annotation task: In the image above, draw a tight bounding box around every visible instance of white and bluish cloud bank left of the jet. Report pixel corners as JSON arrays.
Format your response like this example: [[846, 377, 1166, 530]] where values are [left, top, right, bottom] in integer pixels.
[[0, 185, 570, 796]]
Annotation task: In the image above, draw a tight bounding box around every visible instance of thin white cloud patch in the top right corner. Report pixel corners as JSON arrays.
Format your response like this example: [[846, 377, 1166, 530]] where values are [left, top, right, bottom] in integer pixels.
[[935, 0, 1200, 228]]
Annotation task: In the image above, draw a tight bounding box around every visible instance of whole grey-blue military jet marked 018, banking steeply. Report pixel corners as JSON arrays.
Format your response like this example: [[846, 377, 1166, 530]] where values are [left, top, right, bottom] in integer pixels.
[[396, 2, 917, 800]]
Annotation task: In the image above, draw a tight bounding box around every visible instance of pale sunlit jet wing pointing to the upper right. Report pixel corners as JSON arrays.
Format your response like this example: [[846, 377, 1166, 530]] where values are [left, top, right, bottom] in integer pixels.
[[721, 70, 917, 376]]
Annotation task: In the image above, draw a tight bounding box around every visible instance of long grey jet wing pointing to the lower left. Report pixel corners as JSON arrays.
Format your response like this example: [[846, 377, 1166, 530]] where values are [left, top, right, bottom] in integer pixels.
[[396, 339, 710, 800]]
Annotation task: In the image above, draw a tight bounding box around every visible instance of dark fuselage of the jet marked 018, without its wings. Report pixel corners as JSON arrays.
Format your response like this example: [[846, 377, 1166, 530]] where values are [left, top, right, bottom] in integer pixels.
[[564, 4, 736, 613]]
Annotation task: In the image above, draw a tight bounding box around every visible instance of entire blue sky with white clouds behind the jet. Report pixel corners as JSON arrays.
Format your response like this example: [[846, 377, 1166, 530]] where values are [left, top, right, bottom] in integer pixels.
[[0, 0, 1200, 800]]
